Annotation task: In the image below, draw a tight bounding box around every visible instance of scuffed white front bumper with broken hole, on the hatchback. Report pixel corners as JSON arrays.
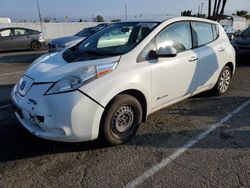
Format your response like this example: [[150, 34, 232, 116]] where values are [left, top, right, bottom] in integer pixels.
[[11, 84, 104, 142]]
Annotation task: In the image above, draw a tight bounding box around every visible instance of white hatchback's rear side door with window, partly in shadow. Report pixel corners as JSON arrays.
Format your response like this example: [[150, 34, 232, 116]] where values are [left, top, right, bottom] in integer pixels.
[[192, 21, 221, 90]]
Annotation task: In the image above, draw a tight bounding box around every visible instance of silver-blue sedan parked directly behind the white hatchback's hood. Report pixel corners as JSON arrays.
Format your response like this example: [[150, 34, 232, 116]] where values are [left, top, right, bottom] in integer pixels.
[[48, 23, 108, 52]]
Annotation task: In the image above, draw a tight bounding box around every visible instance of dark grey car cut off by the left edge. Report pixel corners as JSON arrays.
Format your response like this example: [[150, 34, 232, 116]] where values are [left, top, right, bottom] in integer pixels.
[[0, 27, 44, 51]]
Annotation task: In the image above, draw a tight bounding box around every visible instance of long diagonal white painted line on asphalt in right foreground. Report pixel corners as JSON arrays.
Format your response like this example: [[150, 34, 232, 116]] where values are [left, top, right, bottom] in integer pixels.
[[125, 101, 250, 188]]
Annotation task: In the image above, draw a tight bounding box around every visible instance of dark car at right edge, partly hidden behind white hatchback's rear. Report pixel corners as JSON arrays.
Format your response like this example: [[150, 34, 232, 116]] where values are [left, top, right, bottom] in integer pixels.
[[232, 27, 250, 56]]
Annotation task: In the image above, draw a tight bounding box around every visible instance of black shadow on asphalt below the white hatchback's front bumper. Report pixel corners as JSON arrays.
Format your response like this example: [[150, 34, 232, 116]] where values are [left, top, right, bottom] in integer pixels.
[[0, 107, 108, 163]]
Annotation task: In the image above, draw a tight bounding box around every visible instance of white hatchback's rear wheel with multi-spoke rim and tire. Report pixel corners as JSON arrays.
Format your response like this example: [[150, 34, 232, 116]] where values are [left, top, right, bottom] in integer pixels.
[[212, 66, 232, 96]]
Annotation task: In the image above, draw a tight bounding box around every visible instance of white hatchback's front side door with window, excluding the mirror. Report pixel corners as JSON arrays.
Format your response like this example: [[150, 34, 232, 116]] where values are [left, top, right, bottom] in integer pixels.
[[151, 21, 199, 108]]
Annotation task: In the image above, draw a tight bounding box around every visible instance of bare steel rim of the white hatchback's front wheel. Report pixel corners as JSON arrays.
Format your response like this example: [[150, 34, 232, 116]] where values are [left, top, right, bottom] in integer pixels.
[[112, 106, 134, 134]]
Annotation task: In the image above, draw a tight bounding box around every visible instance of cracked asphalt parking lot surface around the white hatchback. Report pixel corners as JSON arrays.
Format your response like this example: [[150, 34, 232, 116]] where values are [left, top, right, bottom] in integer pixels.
[[0, 51, 250, 188]]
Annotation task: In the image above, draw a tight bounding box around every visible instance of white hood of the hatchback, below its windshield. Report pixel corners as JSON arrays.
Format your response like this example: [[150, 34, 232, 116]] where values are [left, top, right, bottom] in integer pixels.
[[25, 52, 120, 83]]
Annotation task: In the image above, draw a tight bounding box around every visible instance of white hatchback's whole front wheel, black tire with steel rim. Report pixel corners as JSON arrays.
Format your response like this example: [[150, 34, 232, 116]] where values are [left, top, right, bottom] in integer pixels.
[[100, 95, 142, 145]]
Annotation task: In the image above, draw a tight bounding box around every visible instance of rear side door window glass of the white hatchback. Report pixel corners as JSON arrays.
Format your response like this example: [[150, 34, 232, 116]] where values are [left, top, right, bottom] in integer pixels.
[[192, 22, 214, 47]]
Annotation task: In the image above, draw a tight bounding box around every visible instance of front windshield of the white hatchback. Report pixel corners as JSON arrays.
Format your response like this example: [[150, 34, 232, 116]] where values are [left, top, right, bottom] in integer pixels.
[[64, 22, 158, 62]]
